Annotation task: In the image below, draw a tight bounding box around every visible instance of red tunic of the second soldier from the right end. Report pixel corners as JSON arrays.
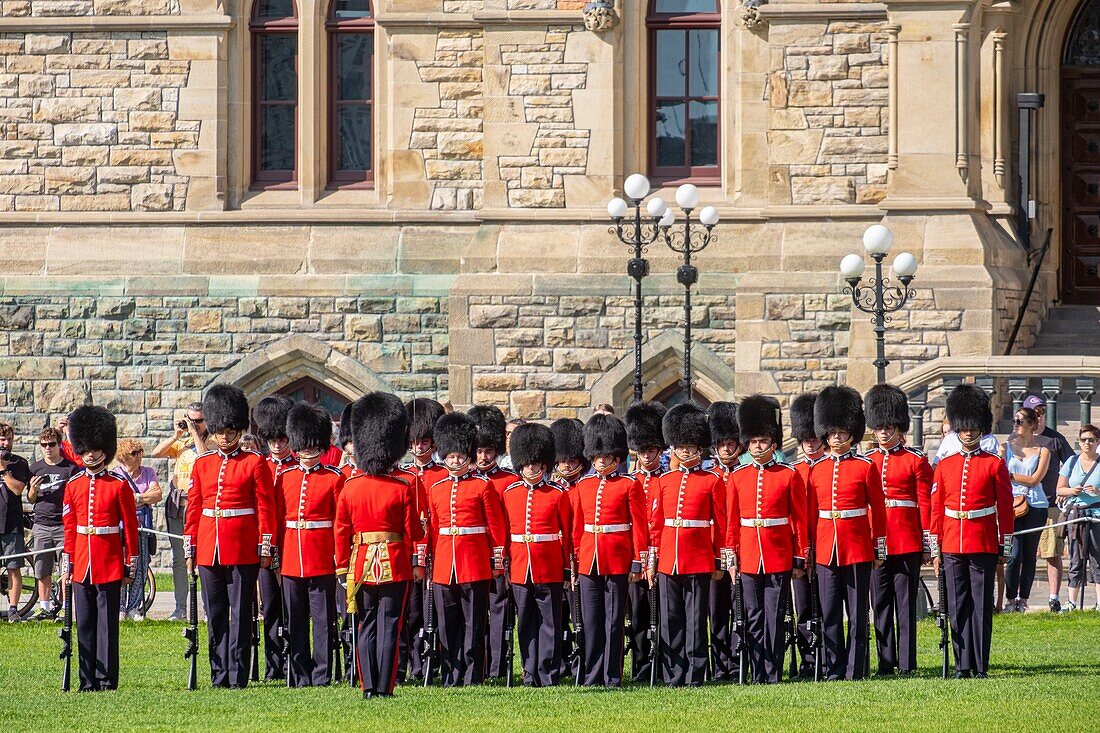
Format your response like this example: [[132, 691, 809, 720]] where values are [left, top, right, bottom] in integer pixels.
[[867, 444, 932, 555]]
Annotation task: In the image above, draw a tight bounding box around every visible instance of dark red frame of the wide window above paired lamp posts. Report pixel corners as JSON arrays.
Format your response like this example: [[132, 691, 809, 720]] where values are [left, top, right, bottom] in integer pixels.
[[646, 0, 722, 186]]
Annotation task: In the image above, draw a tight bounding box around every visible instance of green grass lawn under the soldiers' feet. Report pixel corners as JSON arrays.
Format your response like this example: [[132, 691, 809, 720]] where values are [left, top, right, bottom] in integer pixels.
[[0, 612, 1100, 733]]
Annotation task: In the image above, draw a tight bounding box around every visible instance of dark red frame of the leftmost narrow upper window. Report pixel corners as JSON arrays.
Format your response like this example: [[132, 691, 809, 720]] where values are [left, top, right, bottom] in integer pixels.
[[249, 0, 300, 189]]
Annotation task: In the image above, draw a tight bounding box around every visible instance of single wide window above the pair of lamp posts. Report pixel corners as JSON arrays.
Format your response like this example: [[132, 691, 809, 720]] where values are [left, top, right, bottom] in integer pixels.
[[646, 0, 722, 183]]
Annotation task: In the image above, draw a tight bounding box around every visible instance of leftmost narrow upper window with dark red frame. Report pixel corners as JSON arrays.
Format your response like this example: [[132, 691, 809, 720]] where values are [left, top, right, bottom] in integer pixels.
[[249, 0, 298, 187]]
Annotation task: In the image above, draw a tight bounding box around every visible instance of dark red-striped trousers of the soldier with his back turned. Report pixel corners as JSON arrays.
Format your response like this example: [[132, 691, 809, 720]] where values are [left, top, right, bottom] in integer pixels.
[[355, 580, 410, 694]]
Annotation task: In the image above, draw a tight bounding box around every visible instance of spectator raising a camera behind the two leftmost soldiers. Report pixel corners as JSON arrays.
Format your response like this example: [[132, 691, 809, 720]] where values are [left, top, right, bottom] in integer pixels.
[[153, 402, 215, 621]]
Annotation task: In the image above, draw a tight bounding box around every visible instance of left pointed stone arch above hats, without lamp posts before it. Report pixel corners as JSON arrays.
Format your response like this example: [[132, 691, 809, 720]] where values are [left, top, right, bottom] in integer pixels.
[[213, 335, 391, 403]]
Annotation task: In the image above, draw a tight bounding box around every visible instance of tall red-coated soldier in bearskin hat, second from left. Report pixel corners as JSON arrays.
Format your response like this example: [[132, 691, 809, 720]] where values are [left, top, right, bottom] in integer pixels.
[[184, 384, 275, 688]]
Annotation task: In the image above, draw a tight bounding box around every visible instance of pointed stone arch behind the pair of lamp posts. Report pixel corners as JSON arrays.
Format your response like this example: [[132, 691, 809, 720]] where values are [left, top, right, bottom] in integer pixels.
[[591, 331, 734, 415]]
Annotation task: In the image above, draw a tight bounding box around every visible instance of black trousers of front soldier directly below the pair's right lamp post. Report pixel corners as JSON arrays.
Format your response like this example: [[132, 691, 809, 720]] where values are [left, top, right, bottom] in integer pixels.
[[657, 572, 711, 687]]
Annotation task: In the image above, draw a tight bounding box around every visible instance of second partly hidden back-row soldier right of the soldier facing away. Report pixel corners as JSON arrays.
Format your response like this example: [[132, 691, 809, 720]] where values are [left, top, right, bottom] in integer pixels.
[[466, 405, 519, 679]]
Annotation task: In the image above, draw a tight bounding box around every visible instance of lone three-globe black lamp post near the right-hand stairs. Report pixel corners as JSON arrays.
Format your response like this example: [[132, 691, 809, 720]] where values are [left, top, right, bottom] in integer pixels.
[[840, 225, 916, 384]]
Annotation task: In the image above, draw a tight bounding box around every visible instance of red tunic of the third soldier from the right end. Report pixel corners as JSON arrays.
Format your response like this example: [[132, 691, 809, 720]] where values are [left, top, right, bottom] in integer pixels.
[[810, 451, 887, 565]]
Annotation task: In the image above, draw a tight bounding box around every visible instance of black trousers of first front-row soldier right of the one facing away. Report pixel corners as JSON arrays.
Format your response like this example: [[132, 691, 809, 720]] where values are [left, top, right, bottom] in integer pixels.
[[431, 580, 491, 687]]
